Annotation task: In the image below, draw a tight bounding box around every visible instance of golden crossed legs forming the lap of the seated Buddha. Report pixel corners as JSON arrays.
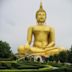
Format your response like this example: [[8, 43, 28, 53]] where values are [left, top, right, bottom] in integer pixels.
[[19, 45, 63, 53]]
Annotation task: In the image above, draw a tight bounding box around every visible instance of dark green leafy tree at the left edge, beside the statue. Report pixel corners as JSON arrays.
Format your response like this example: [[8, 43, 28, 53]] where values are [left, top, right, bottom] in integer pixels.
[[0, 41, 13, 59]]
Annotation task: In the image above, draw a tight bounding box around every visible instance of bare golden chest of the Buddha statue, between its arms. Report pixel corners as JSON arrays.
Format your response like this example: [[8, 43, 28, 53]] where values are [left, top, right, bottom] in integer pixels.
[[33, 28, 50, 41]]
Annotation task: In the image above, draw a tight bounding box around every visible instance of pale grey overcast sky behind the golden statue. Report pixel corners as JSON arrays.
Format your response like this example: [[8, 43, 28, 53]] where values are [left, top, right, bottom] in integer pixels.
[[0, 0, 72, 53]]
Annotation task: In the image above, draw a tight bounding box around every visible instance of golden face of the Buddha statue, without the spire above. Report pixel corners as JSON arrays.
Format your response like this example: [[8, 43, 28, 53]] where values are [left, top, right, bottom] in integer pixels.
[[36, 11, 46, 23]]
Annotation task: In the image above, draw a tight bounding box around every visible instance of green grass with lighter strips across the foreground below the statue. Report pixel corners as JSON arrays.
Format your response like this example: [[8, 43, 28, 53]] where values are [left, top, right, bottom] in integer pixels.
[[0, 61, 72, 72]]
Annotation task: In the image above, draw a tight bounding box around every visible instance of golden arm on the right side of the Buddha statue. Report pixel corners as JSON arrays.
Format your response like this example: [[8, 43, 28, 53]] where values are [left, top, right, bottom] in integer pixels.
[[47, 28, 55, 47]]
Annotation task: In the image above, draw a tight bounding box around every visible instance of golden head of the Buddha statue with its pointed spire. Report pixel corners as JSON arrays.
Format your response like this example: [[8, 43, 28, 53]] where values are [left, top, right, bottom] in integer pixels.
[[36, 2, 46, 23]]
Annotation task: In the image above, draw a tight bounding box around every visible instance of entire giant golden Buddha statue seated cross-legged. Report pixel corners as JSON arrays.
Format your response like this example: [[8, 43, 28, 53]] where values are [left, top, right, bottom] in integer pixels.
[[18, 3, 65, 57]]
